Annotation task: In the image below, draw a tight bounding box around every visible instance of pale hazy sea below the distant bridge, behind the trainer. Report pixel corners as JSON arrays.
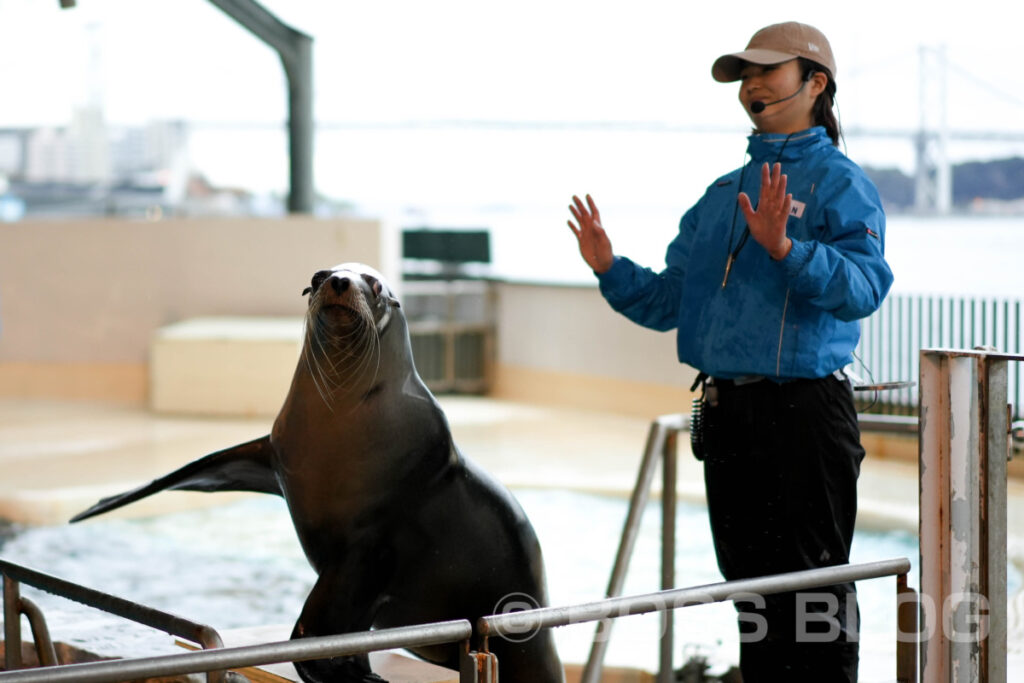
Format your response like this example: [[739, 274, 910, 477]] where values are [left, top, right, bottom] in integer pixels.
[[189, 122, 1024, 298]]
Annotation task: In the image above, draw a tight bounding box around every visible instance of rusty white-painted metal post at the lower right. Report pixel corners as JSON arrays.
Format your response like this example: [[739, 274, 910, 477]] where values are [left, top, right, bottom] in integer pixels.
[[920, 349, 1011, 683]]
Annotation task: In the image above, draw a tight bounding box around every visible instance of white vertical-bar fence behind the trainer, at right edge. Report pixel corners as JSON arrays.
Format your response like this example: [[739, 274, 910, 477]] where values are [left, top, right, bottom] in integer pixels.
[[856, 294, 1024, 419]]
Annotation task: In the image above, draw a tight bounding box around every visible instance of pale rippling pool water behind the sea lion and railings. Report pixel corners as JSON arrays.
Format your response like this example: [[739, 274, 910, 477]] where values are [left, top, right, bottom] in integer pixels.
[[0, 489, 1021, 681]]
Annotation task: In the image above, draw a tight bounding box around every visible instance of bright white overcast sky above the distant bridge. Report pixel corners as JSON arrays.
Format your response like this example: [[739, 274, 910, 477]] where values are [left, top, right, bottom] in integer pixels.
[[0, 0, 1024, 201]]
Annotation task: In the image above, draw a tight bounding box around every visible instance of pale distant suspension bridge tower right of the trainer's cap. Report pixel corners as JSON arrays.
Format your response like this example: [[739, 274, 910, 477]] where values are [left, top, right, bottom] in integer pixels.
[[914, 45, 953, 214]]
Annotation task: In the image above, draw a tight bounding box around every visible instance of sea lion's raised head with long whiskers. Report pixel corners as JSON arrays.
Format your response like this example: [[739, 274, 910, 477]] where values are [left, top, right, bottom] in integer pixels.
[[302, 263, 400, 403]]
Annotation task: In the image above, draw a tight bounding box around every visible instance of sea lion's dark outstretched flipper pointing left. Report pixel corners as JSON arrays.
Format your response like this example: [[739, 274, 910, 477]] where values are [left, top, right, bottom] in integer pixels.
[[71, 436, 282, 522]]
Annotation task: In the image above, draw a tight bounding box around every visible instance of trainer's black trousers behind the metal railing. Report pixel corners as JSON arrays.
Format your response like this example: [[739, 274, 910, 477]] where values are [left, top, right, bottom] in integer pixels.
[[705, 376, 864, 683]]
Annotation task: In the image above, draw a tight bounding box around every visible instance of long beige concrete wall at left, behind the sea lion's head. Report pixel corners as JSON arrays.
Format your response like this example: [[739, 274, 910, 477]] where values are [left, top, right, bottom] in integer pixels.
[[0, 217, 398, 401]]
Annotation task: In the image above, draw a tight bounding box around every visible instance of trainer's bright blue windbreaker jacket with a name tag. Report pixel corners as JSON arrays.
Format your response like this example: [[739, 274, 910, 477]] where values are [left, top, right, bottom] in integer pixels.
[[598, 127, 893, 381]]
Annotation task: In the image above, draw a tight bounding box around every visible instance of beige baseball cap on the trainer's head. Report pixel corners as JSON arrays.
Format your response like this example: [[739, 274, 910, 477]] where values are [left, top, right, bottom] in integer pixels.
[[711, 22, 836, 83]]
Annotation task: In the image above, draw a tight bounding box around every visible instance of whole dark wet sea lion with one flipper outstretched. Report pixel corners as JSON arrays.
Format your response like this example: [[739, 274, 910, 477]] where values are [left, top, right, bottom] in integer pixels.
[[72, 263, 563, 683]]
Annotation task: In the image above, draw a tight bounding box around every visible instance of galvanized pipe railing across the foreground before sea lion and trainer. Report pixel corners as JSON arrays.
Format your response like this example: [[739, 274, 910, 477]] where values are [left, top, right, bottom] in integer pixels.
[[0, 558, 916, 683]]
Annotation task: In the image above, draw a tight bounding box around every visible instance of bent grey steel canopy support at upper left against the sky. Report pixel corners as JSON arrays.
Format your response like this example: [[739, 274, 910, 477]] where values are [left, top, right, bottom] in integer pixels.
[[210, 0, 313, 213]]
